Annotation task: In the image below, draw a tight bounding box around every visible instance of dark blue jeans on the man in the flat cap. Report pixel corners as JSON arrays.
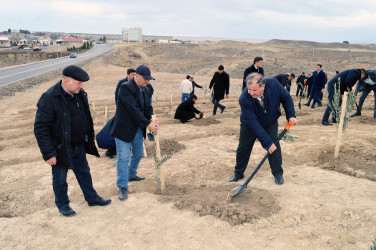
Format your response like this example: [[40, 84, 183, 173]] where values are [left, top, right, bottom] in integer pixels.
[[52, 144, 98, 208]]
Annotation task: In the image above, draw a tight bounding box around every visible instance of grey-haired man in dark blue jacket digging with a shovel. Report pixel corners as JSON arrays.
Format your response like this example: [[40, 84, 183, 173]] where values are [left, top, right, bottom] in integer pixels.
[[229, 73, 296, 185]]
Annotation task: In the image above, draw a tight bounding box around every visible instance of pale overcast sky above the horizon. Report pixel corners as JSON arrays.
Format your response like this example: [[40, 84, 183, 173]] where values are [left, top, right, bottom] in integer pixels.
[[0, 0, 376, 43]]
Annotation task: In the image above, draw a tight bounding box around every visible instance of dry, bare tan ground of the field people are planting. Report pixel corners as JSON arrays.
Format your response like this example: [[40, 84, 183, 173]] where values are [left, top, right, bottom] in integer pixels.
[[0, 42, 376, 249]]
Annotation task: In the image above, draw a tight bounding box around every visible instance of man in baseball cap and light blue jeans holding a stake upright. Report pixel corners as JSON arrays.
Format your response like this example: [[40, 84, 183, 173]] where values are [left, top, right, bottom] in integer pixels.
[[110, 65, 159, 201]]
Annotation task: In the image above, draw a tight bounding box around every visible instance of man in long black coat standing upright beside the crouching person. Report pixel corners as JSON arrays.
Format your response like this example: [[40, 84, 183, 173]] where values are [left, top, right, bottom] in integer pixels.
[[208, 65, 230, 116]]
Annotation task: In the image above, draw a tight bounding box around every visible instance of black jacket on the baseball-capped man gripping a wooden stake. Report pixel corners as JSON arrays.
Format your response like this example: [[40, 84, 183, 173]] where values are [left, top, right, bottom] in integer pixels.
[[110, 79, 153, 142]]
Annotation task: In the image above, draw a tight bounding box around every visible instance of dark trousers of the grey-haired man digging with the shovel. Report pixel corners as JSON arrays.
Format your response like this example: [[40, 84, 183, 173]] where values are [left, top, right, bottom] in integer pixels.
[[235, 121, 283, 178]]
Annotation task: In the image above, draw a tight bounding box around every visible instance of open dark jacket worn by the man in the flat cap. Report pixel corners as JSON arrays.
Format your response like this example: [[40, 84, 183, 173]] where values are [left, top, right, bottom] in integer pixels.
[[34, 81, 99, 169]]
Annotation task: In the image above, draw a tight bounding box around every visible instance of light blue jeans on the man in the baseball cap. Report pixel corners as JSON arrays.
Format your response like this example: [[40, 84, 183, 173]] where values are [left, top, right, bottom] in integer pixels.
[[115, 128, 144, 190]]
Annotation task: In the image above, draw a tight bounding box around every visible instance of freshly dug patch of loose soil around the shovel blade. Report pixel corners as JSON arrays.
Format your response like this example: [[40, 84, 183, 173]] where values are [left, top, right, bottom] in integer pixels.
[[160, 185, 281, 225]]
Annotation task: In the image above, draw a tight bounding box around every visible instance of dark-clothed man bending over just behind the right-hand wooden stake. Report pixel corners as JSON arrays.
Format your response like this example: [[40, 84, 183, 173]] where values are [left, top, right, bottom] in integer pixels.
[[322, 69, 368, 126]]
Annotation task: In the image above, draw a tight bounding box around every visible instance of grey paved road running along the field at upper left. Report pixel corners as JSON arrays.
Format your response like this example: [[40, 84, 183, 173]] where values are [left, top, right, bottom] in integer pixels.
[[0, 44, 114, 87]]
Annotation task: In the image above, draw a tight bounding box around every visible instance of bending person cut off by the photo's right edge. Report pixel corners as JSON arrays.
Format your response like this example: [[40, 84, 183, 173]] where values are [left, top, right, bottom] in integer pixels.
[[350, 69, 376, 119]]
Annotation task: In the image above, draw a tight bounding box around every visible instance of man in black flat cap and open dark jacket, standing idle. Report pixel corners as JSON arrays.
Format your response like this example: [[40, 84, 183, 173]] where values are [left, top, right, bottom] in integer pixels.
[[34, 65, 111, 216]]
